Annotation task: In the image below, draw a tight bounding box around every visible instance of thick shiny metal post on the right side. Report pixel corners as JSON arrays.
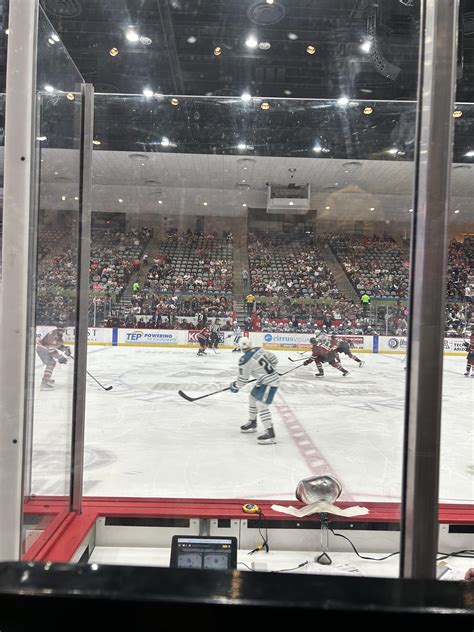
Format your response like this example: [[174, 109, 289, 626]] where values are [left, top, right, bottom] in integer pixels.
[[400, 0, 459, 579]]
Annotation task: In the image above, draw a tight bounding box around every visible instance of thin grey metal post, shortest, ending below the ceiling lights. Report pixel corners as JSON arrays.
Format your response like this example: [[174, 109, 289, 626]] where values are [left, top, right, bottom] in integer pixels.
[[70, 84, 94, 513]]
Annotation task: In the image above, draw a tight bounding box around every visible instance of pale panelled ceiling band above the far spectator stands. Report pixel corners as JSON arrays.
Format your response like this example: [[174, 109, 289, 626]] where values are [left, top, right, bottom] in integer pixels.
[[10, 149, 474, 225]]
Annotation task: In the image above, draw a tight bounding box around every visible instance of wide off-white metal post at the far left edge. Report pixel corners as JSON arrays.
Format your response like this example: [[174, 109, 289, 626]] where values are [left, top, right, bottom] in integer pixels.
[[0, 0, 38, 560]]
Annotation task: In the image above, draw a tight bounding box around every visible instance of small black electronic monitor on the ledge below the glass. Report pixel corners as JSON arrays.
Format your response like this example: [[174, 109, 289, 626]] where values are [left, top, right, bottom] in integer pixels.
[[170, 535, 237, 571]]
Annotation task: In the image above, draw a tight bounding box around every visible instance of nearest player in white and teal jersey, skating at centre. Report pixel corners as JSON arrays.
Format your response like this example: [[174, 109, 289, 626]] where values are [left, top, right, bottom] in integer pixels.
[[230, 337, 280, 444]]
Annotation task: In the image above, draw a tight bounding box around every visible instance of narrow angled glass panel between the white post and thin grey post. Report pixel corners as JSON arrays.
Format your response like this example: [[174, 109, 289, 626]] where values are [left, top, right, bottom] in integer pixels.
[[23, 10, 82, 553]]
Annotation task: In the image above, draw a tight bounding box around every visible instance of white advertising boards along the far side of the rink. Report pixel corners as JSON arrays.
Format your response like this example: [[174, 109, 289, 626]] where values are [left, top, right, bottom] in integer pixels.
[[36, 326, 466, 356]]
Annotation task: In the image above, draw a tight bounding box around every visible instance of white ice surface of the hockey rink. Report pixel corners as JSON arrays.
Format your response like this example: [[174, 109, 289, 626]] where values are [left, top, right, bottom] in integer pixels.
[[32, 347, 474, 502]]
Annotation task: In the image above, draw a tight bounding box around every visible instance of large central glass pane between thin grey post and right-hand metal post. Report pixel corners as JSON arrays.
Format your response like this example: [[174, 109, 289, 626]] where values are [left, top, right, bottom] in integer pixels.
[[43, 0, 426, 574]]
